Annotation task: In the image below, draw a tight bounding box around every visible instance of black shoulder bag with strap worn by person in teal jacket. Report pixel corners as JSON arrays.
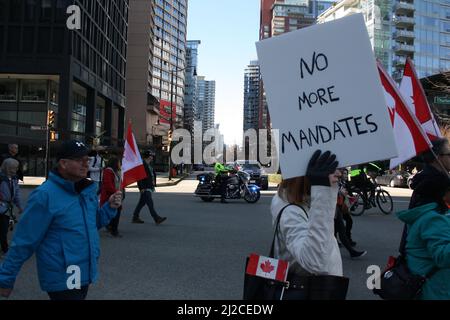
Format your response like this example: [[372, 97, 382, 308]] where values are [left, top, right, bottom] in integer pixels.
[[373, 225, 439, 300]]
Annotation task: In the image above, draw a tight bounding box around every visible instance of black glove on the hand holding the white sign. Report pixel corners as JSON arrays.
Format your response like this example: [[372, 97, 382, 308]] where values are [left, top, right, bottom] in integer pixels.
[[306, 150, 338, 186]]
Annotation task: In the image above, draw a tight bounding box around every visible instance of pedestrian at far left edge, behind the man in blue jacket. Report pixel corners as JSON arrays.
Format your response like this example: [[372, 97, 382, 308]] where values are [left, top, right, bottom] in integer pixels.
[[0, 158, 23, 253]]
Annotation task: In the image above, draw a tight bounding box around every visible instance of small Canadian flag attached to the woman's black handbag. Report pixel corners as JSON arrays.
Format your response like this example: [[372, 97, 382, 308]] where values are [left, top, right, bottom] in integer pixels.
[[246, 253, 289, 282]]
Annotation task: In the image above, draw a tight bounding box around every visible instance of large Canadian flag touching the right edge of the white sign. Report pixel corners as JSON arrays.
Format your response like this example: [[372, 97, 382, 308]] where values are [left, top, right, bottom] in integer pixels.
[[378, 61, 431, 169]]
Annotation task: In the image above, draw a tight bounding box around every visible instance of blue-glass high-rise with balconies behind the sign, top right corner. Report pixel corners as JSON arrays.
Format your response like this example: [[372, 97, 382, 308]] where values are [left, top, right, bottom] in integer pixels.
[[318, 0, 450, 81]]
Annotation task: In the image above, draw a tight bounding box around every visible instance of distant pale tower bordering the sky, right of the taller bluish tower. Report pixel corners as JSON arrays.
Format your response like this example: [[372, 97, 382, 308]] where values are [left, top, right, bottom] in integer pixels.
[[197, 76, 216, 132]]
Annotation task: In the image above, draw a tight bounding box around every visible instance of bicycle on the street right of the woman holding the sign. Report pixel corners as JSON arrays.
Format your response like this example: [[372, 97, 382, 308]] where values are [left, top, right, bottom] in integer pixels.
[[346, 182, 394, 216]]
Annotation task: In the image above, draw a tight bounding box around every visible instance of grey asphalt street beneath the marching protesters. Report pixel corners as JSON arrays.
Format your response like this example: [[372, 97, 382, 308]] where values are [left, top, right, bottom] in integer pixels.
[[5, 172, 410, 300]]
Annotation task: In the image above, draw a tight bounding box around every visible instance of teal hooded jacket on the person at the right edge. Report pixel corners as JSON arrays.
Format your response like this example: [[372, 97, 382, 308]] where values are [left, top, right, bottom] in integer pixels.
[[397, 203, 450, 300]]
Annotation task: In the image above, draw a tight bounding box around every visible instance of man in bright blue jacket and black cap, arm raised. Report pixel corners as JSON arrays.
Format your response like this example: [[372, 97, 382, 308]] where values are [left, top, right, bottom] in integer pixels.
[[0, 140, 122, 300]]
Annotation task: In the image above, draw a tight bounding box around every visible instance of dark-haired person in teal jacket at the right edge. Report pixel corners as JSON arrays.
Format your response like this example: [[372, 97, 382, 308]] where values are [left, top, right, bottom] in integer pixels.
[[397, 171, 450, 300]]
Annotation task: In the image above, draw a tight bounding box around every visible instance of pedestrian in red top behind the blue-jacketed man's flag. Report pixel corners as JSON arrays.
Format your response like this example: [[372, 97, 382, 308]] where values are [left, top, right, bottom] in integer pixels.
[[100, 157, 124, 237]]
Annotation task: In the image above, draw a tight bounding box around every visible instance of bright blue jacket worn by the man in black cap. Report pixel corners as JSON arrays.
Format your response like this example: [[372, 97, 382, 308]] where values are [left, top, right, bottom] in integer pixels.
[[0, 172, 117, 292]]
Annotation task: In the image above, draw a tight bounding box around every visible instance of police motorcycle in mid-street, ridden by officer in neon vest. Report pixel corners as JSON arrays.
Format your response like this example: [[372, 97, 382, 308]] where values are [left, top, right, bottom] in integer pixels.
[[195, 170, 261, 203]]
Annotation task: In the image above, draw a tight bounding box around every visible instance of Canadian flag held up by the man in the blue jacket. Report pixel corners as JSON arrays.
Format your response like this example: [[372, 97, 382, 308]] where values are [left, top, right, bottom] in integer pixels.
[[120, 123, 147, 189]]
